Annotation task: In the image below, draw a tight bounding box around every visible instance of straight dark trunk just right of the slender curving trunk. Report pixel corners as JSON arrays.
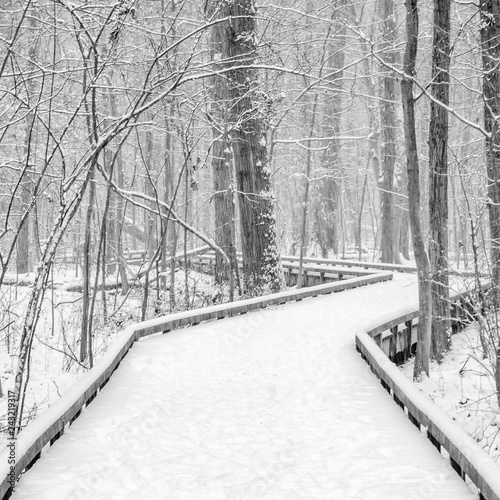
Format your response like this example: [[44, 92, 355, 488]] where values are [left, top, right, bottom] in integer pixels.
[[429, 0, 451, 362]]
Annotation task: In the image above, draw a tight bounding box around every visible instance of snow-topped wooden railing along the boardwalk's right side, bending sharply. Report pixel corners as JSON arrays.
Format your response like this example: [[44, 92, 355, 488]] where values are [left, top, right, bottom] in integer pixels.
[[356, 295, 500, 500]]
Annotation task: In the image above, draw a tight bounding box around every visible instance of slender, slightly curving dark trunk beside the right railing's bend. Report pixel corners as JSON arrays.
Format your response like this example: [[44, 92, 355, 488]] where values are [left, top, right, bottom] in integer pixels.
[[401, 0, 432, 379]]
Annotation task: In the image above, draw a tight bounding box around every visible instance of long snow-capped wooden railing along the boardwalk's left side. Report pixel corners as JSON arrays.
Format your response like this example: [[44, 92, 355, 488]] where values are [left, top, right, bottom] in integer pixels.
[[0, 272, 392, 500]]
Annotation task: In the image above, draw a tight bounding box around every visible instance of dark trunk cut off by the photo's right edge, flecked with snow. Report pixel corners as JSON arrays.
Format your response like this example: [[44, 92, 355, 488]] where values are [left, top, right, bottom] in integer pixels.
[[479, 0, 500, 307]]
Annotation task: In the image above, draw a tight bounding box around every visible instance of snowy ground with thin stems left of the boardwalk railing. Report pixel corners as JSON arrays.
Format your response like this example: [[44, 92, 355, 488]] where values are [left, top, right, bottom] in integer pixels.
[[0, 270, 227, 448]]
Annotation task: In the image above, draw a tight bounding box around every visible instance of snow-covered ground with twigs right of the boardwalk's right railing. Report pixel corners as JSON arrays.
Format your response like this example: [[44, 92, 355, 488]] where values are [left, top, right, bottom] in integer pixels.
[[402, 325, 500, 462]]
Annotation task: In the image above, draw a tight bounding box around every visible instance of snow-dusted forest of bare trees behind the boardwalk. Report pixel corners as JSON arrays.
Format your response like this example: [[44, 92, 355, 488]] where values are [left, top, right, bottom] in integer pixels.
[[0, 0, 500, 460]]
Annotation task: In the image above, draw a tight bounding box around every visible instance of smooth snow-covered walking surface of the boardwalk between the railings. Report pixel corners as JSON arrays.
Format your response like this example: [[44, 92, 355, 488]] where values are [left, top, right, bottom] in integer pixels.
[[12, 275, 475, 500]]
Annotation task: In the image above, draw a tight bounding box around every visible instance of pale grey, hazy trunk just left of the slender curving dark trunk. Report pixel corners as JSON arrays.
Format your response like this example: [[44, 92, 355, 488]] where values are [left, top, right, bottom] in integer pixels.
[[378, 0, 399, 263]]
